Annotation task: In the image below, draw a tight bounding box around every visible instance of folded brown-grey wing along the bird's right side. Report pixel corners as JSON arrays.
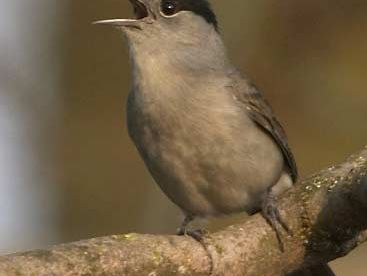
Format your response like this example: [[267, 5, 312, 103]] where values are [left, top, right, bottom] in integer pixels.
[[233, 76, 298, 182]]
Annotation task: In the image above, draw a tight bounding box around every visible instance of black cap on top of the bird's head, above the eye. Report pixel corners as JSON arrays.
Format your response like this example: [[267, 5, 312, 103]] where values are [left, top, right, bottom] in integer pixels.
[[162, 0, 218, 30]]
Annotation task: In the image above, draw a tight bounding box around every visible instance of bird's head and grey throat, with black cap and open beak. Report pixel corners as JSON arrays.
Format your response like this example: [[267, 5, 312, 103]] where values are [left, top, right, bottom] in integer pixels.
[[95, 0, 231, 75]]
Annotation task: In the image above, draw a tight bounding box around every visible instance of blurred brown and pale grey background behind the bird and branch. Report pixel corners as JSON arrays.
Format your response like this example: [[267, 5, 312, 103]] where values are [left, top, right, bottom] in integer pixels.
[[0, 0, 367, 276]]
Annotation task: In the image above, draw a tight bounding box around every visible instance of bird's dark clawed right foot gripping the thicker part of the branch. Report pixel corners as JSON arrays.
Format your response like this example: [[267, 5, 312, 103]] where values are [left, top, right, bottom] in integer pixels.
[[261, 192, 293, 252]]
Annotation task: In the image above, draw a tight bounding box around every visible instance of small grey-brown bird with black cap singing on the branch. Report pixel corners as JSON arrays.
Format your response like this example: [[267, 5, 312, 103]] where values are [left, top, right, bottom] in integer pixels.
[[95, 0, 332, 275]]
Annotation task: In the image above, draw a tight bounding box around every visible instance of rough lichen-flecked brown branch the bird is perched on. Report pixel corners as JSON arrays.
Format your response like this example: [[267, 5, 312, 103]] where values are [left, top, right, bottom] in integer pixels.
[[0, 147, 367, 276]]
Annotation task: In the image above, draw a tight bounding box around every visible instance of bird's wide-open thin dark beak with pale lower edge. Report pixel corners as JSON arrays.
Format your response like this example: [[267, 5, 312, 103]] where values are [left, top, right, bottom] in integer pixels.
[[93, 0, 149, 29]]
